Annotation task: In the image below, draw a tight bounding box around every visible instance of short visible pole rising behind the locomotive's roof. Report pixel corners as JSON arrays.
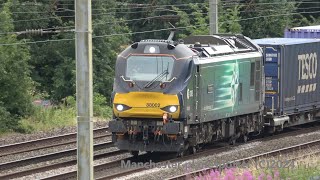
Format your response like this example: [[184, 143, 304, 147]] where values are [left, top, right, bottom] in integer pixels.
[[209, 0, 218, 35]]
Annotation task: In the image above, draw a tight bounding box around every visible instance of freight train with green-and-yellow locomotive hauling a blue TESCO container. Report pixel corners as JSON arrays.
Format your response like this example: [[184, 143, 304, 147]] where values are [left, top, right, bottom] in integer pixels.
[[109, 34, 320, 156]]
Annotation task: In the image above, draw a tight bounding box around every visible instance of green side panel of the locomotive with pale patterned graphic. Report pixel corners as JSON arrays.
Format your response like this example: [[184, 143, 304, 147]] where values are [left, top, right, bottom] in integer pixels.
[[198, 53, 262, 121]]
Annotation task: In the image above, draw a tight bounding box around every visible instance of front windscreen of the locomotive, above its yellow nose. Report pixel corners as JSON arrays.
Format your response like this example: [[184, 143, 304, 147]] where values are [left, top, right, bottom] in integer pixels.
[[126, 56, 174, 81]]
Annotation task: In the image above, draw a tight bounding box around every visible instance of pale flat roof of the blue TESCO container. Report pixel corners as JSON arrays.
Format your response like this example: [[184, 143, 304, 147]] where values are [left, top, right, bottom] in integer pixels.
[[253, 38, 320, 45]]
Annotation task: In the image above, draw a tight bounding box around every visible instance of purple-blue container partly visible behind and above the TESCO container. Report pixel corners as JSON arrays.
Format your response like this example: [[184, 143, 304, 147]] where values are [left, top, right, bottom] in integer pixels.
[[284, 25, 320, 39]]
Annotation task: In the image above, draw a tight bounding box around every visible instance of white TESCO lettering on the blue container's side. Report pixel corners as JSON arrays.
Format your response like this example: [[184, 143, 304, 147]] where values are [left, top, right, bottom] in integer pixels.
[[298, 53, 318, 80]]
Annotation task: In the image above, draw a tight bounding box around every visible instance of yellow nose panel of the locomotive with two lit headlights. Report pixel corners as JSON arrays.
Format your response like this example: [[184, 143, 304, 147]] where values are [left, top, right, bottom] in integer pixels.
[[113, 92, 180, 119]]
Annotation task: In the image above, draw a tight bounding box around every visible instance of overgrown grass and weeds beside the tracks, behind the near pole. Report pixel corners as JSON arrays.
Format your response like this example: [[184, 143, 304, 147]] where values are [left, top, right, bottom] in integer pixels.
[[0, 93, 112, 133]]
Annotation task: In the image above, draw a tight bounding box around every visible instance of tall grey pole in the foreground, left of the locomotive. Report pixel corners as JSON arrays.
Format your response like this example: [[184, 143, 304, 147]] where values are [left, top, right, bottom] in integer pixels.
[[75, 0, 93, 180]]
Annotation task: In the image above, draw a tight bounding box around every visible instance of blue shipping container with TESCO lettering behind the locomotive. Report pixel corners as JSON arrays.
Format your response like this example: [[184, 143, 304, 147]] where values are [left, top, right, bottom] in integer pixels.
[[254, 38, 320, 116]]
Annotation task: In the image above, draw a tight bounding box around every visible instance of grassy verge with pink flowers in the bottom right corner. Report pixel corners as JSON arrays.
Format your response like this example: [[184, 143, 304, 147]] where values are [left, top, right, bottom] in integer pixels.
[[191, 152, 320, 180]]
